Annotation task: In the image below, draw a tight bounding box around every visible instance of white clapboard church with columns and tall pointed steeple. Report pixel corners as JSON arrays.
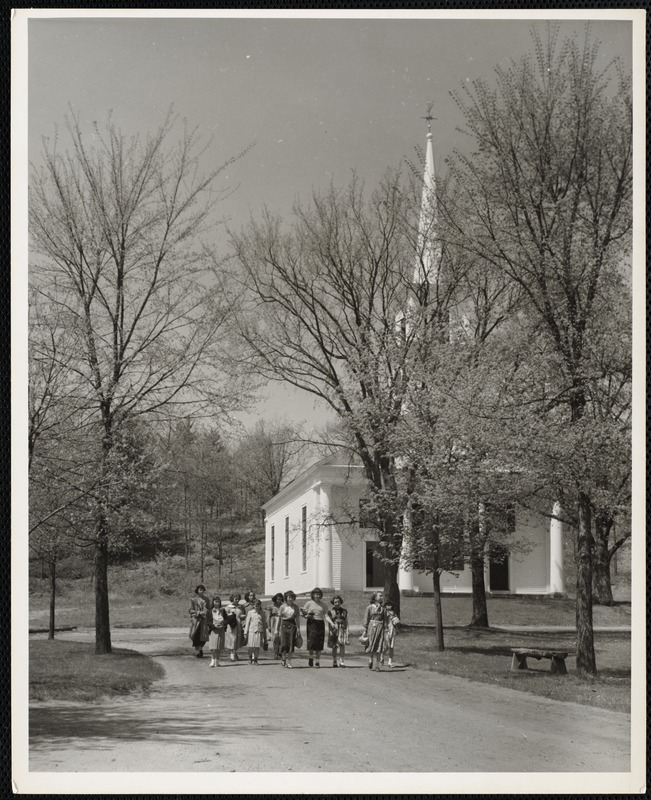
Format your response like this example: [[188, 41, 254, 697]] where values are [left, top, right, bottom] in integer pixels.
[[263, 122, 564, 594]]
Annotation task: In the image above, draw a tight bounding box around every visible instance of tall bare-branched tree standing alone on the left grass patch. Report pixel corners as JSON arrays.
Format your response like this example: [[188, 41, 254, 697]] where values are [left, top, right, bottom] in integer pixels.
[[30, 114, 250, 653]]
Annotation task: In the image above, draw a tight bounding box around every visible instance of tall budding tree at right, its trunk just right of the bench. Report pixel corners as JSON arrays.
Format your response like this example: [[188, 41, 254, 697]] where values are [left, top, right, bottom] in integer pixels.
[[450, 25, 632, 674]]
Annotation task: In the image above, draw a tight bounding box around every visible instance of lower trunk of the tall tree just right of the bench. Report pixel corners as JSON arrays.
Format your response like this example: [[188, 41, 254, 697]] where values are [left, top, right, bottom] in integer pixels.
[[576, 492, 597, 676]]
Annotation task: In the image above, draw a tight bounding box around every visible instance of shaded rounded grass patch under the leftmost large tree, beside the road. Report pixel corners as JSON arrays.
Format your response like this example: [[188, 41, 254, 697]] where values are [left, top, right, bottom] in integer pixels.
[[29, 639, 164, 701]]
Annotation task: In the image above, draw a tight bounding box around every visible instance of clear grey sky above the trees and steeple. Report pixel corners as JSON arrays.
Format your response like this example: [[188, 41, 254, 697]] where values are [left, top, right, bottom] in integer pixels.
[[28, 10, 631, 434]]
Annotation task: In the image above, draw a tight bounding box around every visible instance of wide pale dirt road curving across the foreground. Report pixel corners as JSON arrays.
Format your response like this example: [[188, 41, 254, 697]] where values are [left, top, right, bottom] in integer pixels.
[[29, 628, 630, 772]]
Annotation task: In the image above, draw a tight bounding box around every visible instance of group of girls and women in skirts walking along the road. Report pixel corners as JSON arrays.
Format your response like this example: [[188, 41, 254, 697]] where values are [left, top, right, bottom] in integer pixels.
[[190, 584, 400, 670]]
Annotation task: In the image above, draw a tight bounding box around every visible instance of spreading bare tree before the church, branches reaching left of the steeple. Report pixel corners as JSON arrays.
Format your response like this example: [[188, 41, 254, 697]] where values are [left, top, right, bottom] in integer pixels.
[[233, 174, 460, 609]]
